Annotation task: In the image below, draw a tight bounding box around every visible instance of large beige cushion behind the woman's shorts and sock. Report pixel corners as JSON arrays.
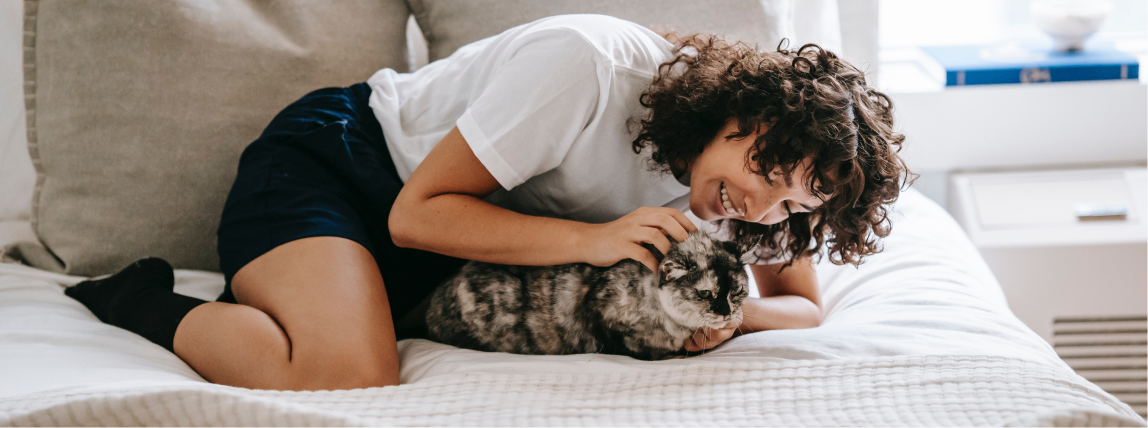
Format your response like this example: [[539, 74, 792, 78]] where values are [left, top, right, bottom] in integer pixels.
[[25, 0, 409, 275]]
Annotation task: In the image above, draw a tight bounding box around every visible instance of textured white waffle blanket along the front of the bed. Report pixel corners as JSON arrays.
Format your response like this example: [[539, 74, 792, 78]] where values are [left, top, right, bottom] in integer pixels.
[[0, 356, 1146, 427]]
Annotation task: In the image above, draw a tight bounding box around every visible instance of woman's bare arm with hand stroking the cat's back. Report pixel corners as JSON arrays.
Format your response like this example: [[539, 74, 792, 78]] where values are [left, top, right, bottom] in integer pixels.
[[388, 127, 696, 271]]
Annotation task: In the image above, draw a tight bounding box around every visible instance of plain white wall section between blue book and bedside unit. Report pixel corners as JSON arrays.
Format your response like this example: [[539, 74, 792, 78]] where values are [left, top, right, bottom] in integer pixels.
[[892, 81, 1148, 171]]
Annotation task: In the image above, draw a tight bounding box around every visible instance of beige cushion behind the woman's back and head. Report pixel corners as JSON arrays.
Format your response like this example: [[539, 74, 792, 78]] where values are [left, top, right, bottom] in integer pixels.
[[408, 0, 793, 61]]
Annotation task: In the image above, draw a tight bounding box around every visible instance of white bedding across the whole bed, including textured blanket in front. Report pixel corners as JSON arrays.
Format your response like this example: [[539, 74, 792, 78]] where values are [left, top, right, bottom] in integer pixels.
[[0, 190, 1148, 427]]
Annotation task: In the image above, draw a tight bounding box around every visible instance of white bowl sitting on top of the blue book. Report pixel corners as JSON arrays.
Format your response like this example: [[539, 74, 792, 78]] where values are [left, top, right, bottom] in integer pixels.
[[1029, 0, 1112, 52]]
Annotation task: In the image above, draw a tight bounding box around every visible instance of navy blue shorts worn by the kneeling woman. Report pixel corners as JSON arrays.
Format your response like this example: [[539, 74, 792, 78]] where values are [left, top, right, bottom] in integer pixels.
[[218, 84, 465, 321]]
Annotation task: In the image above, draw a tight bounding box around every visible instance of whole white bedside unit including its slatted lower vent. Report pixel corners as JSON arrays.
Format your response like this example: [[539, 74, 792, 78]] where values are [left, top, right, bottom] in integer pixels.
[[948, 166, 1148, 412]]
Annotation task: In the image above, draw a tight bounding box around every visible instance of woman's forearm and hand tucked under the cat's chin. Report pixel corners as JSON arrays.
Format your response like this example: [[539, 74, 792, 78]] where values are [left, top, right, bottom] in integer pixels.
[[685, 253, 821, 352]]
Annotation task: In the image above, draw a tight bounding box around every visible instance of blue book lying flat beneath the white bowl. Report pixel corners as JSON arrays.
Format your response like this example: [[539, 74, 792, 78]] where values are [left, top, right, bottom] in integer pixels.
[[922, 45, 1140, 86]]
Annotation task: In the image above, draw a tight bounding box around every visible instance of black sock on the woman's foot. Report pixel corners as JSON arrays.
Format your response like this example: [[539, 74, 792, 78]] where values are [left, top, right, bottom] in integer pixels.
[[64, 257, 207, 351]]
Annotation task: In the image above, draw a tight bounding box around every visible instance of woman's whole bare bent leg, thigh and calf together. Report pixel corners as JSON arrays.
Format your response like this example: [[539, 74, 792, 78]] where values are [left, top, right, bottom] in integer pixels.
[[174, 236, 398, 390]]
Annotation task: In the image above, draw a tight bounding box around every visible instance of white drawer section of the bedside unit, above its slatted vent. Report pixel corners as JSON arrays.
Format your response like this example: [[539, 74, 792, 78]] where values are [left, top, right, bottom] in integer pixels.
[[948, 166, 1148, 335]]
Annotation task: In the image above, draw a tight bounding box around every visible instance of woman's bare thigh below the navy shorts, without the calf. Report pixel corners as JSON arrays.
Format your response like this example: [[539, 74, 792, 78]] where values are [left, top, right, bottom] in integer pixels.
[[216, 236, 398, 390]]
